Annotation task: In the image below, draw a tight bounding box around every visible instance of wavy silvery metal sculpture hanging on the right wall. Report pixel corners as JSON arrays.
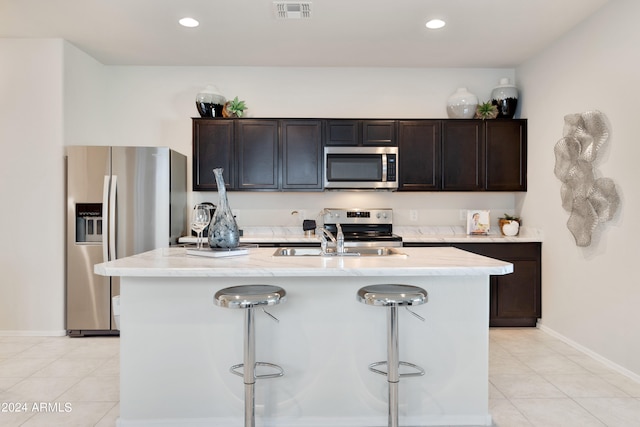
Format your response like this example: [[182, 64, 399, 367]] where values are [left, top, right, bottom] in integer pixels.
[[554, 111, 620, 246]]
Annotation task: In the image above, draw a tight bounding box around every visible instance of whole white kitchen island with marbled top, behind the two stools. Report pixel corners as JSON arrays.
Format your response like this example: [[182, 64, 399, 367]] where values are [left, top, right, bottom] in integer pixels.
[[95, 248, 513, 427]]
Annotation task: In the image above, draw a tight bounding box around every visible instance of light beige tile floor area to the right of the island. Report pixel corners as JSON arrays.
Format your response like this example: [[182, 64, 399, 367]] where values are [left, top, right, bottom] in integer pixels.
[[489, 328, 640, 427]]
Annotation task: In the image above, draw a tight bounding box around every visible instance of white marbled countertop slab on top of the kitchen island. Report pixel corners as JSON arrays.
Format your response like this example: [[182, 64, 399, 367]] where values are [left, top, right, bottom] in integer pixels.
[[94, 247, 513, 277]]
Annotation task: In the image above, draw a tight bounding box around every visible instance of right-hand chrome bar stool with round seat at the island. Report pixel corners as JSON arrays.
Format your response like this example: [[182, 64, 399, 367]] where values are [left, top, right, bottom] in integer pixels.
[[357, 284, 427, 427]]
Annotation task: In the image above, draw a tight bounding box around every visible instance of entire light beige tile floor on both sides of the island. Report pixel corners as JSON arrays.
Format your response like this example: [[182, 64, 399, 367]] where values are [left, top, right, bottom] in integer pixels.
[[0, 328, 640, 427]]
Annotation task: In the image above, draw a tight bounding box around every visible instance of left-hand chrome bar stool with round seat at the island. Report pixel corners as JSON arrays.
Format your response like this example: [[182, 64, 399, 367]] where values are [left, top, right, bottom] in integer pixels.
[[213, 285, 287, 427]]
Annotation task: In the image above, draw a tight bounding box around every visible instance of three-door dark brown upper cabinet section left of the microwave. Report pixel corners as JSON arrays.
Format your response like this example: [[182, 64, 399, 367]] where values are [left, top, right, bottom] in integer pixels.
[[193, 118, 322, 191]]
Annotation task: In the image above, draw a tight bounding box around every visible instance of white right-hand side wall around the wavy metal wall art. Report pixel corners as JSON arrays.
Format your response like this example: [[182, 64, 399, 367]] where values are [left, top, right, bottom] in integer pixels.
[[517, 0, 640, 375]]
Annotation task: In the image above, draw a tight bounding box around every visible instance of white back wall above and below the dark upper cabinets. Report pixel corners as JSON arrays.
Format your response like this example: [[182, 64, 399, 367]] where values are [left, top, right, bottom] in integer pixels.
[[107, 67, 514, 227]]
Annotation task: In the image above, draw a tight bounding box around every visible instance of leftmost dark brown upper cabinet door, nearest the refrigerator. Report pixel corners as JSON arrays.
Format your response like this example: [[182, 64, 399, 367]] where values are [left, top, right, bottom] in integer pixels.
[[192, 119, 236, 191]]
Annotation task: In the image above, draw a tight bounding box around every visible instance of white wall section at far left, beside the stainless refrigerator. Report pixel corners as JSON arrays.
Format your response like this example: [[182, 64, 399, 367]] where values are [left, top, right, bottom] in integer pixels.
[[0, 39, 64, 334]]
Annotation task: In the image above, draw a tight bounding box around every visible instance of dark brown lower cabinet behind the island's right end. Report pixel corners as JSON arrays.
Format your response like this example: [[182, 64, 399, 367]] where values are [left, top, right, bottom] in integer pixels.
[[405, 242, 542, 327]]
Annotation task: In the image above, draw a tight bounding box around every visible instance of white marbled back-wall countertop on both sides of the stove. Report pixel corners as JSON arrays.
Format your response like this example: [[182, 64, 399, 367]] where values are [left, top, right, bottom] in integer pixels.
[[179, 225, 543, 244]]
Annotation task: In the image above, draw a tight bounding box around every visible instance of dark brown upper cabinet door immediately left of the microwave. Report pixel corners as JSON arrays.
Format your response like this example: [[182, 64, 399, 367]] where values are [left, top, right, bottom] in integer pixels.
[[280, 120, 322, 190]]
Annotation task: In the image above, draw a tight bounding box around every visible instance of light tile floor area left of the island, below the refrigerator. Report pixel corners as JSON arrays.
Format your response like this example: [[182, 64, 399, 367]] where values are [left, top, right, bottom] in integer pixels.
[[0, 337, 120, 427]]
